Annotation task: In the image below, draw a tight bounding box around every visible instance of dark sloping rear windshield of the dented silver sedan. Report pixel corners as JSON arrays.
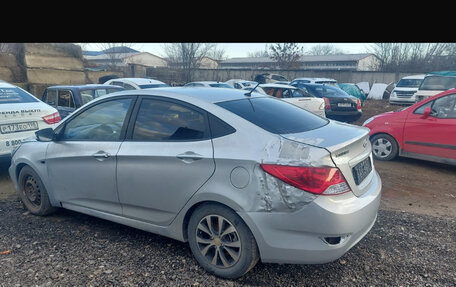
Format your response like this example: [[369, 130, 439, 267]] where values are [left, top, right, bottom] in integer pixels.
[[217, 98, 329, 134]]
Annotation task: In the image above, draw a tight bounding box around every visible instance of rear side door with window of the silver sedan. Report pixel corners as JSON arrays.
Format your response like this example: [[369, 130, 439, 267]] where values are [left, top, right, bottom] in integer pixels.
[[117, 99, 215, 225]]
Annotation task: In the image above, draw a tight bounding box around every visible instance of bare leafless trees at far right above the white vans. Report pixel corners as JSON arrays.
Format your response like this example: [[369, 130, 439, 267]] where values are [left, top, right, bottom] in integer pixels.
[[369, 43, 456, 73]]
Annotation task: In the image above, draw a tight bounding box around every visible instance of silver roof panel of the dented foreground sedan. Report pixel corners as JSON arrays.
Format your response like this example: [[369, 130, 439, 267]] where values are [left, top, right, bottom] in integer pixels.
[[96, 87, 268, 103]]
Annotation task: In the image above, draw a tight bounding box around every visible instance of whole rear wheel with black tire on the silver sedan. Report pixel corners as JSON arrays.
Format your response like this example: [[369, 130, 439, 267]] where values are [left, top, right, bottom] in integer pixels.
[[188, 204, 260, 279]]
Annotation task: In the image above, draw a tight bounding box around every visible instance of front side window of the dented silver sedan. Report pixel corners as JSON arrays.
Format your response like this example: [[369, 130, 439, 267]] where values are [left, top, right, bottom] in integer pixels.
[[63, 99, 131, 141]]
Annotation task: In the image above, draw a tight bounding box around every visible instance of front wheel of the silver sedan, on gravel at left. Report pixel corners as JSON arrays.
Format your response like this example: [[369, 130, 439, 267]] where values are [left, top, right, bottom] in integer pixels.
[[18, 166, 57, 216]]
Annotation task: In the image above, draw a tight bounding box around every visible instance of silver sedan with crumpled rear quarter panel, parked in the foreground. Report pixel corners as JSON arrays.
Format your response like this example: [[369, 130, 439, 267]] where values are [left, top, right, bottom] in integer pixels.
[[9, 87, 381, 278]]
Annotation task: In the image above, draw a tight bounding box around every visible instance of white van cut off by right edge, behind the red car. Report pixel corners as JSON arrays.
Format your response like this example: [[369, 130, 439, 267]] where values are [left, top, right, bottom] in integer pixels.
[[415, 71, 456, 102]]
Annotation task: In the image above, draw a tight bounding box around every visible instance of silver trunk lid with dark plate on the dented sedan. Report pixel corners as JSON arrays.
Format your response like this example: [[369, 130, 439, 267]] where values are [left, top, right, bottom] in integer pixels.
[[282, 121, 374, 196]]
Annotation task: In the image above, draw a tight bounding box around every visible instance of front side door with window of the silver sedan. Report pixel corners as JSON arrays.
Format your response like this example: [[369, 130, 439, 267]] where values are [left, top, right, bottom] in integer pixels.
[[46, 99, 132, 215]]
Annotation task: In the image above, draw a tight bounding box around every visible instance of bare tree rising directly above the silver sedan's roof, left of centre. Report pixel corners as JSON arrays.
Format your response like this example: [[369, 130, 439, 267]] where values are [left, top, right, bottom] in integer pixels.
[[164, 43, 217, 82]]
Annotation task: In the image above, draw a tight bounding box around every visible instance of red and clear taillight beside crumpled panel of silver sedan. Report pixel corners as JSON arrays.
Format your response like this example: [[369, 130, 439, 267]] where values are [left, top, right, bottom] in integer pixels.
[[261, 164, 351, 195]]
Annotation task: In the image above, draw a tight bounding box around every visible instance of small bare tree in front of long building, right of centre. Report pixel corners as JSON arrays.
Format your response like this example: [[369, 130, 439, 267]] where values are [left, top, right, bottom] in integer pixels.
[[269, 43, 304, 69]]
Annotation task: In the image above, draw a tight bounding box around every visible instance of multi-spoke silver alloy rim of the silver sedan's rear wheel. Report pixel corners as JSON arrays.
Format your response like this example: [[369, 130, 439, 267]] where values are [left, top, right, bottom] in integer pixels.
[[196, 214, 242, 268]]
